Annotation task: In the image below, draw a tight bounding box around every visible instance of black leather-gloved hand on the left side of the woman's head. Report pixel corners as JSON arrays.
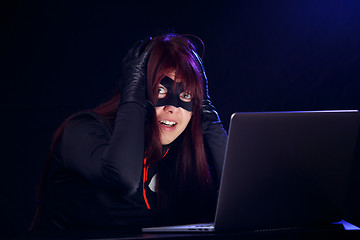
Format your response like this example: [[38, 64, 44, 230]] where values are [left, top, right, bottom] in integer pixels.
[[119, 37, 154, 107]]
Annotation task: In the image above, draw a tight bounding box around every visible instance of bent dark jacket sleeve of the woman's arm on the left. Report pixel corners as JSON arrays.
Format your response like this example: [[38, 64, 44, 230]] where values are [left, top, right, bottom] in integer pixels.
[[60, 103, 146, 195]]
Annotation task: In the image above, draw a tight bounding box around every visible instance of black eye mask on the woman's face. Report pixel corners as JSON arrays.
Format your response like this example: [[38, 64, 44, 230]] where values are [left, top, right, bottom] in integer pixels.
[[156, 76, 192, 112]]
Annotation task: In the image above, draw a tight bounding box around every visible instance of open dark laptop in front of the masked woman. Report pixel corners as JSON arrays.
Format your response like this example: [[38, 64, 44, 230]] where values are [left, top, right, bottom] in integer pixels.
[[142, 110, 359, 232]]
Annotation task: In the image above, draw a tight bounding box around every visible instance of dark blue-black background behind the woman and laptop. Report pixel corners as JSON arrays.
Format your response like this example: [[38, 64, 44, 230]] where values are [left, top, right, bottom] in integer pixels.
[[0, 0, 360, 236]]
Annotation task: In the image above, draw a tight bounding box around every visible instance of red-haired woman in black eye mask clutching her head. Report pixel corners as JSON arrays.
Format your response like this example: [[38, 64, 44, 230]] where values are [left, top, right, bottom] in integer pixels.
[[34, 34, 226, 231]]
